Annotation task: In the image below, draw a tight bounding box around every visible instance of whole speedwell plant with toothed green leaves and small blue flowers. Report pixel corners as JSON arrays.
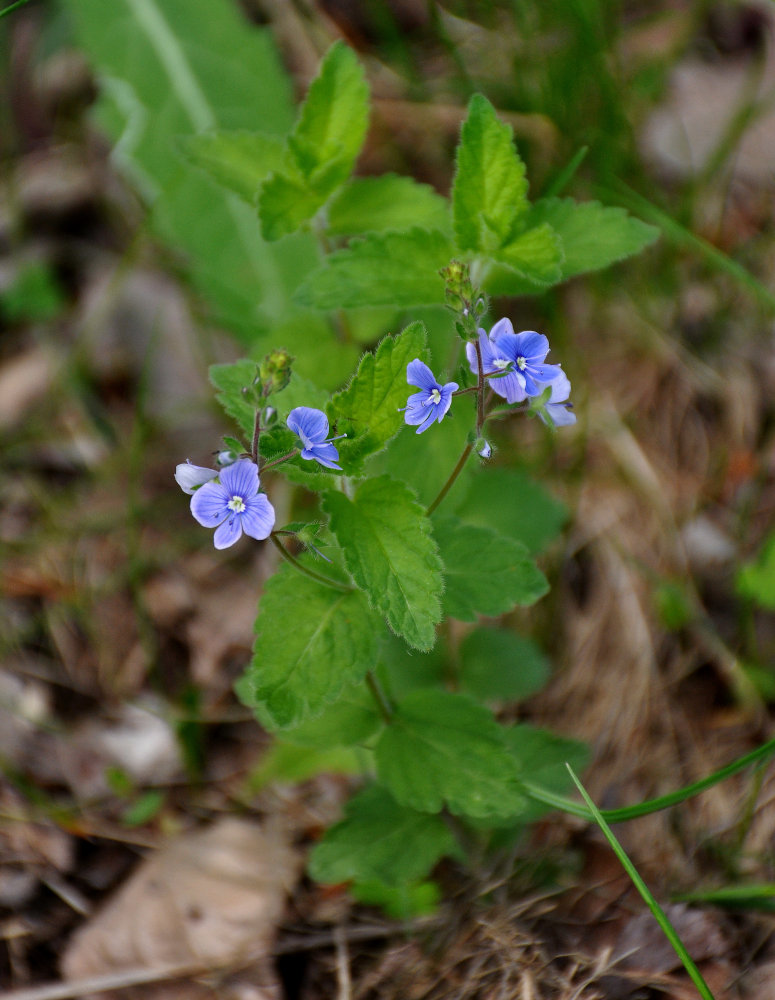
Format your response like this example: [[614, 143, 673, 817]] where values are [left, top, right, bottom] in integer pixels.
[[164, 37, 656, 906]]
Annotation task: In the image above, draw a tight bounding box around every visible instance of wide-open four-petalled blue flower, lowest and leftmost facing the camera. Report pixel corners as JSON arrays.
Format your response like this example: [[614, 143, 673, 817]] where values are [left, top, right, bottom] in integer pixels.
[[191, 458, 275, 549]]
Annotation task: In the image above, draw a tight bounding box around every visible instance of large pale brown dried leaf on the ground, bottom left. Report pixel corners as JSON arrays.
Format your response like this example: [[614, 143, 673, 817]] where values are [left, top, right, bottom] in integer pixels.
[[62, 818, 300, 979]]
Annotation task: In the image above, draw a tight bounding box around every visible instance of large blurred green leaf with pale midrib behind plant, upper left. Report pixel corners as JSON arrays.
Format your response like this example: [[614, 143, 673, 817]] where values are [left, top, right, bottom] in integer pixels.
[[63, 0, 317, 343]]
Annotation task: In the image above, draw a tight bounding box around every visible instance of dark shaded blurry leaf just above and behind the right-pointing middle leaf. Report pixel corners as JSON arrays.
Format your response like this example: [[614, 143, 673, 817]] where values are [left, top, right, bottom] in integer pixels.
[[455, 469, 568, 555]]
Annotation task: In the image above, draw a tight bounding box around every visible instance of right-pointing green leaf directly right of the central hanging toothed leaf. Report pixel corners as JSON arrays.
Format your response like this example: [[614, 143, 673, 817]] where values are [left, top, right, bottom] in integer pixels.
[[433, 517, 549, 622]]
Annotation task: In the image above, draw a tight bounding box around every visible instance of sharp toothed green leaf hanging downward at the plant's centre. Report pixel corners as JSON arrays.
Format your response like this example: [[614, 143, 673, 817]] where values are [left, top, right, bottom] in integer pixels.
[[323, 476, 443, 649]]
